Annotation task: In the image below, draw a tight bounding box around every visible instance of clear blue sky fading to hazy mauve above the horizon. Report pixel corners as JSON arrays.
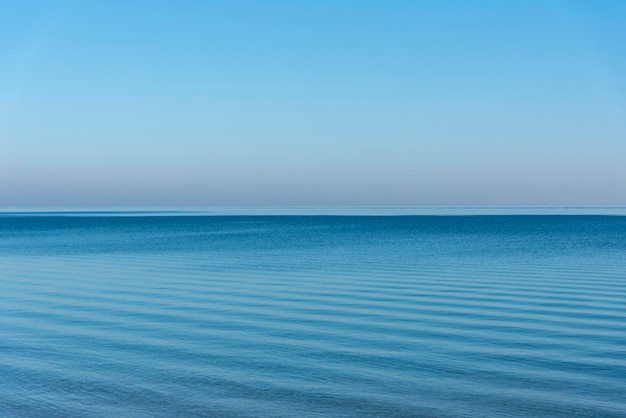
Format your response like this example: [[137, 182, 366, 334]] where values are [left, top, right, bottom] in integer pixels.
[[0, 0, 626, 205]]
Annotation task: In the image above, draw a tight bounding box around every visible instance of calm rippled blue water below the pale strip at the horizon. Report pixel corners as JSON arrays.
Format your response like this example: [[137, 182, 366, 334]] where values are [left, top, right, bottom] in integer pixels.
[[0, 213, 626, 418]]
